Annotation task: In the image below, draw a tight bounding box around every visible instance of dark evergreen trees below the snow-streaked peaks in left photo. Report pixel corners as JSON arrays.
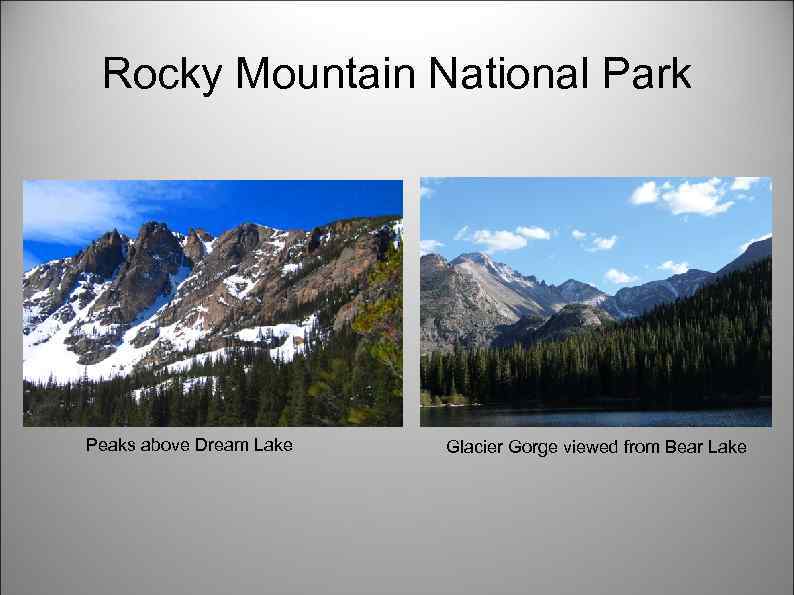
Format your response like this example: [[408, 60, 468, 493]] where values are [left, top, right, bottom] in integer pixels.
[[23, 328, 392, 426]]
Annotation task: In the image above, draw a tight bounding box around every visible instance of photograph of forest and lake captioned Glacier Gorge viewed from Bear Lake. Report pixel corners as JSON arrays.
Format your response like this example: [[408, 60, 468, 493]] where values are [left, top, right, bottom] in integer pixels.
[[420, 177, 772, 427]]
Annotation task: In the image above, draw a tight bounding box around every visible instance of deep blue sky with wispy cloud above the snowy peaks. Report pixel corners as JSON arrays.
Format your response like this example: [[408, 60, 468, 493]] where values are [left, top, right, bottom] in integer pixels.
[[22, 180, 402, 270]]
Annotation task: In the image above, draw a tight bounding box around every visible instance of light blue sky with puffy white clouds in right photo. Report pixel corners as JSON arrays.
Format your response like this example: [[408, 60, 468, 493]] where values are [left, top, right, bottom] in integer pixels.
[[420, 177, 772, 293]]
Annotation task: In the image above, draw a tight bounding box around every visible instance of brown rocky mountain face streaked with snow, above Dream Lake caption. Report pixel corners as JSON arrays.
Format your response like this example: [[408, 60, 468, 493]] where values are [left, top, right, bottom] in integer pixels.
[[22, 217, 401, 380]]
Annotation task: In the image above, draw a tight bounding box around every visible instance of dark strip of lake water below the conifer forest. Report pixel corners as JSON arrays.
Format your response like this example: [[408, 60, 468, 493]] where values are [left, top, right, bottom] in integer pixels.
[[420, 404, 772, 428]]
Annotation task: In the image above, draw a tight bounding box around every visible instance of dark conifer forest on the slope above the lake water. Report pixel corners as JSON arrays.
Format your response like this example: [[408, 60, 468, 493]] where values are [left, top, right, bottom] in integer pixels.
[[421, 259, 772, 407]]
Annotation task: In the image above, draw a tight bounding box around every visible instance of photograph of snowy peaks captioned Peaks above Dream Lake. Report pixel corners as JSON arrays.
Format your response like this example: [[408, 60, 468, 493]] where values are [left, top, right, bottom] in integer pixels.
[[22, 180, 403, 426]]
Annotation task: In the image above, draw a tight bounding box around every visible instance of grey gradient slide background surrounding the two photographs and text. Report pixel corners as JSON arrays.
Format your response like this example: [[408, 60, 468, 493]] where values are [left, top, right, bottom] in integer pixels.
[[2, 3, 792, 595]]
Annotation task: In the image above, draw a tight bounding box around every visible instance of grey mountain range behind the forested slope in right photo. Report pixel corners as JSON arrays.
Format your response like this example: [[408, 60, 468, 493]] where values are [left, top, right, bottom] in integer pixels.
[[420, 238, 772, 354]]
